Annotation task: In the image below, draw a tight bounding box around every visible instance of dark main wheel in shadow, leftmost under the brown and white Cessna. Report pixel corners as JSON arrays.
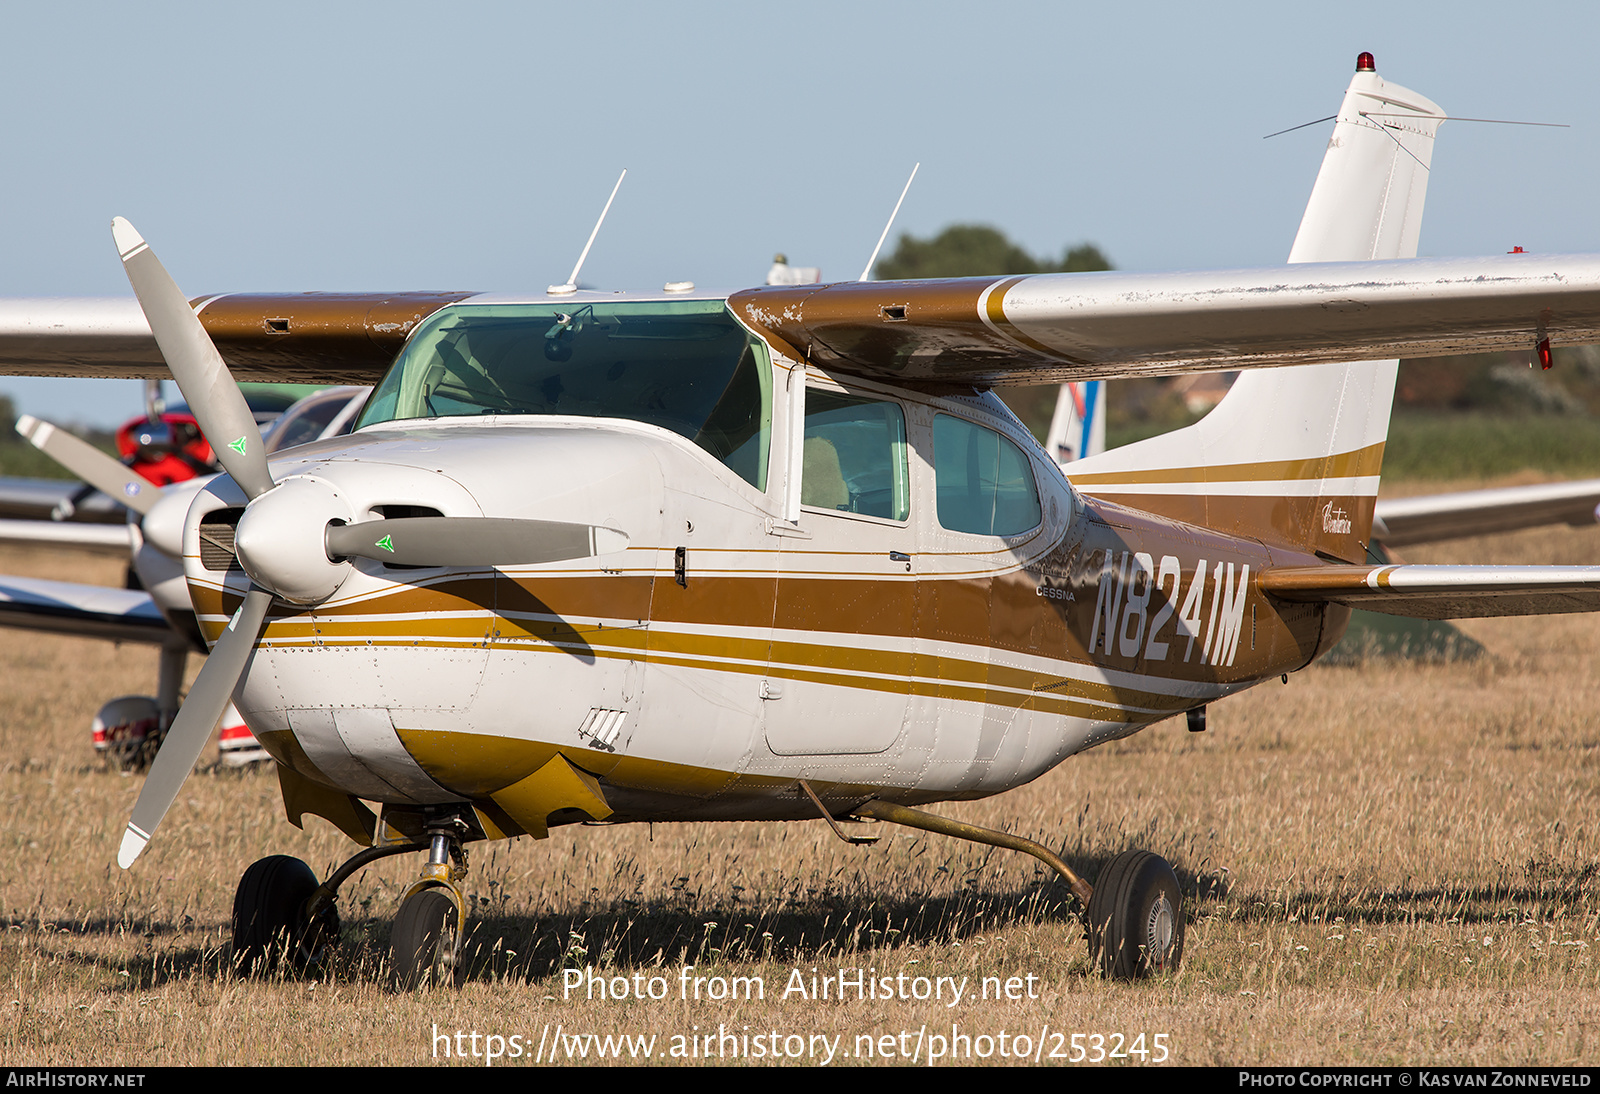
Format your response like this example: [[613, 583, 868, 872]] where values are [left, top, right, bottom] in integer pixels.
[[234, 854, 339, 976]]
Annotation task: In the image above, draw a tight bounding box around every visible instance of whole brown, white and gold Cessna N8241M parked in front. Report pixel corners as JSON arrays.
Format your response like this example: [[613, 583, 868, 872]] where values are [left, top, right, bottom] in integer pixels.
[[6, 54, 1600, 985]]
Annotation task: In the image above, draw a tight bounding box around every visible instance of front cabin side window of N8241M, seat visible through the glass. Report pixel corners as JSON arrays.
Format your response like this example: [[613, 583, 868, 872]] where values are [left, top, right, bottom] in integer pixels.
[[800, 387, 910, 520]]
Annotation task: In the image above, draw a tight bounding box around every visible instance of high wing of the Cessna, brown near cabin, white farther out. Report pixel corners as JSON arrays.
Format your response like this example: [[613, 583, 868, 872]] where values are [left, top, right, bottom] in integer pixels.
[[9, 254, 1600, 385]]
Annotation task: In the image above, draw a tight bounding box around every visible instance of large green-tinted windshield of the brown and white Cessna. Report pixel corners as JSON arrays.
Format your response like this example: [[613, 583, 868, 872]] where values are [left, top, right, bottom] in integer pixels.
[[362, 301, 773, 489]]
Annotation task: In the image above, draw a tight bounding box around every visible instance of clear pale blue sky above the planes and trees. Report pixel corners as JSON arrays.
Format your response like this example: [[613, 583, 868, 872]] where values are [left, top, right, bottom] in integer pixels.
[[0, 0, 1600, 424]]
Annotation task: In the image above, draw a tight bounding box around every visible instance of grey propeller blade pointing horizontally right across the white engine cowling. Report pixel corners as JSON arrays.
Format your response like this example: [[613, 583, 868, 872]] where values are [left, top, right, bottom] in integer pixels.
[[326, 517, 627, 566]]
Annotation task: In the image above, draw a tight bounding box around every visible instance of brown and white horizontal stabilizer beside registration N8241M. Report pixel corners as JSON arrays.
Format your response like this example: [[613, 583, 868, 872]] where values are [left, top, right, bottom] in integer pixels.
[[1261, 566, 1600, 619]]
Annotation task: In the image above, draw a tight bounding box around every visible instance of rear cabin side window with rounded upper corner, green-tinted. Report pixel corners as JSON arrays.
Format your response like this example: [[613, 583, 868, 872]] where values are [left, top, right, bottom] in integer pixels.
[[933, 414, 1040, 536]]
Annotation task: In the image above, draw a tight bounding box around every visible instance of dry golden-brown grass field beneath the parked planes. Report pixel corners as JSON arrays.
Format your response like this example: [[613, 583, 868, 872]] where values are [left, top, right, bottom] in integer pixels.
[[0, 485, 1600, 1065]]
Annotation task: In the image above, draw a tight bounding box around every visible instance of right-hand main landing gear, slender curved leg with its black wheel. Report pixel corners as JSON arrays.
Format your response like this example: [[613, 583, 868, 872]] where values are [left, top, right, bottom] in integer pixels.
[[853, 801, 1184, 980]]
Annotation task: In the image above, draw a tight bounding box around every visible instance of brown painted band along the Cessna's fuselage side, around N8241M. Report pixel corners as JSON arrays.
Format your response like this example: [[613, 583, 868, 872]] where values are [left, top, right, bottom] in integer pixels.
[[195, 499, 1320, 691]]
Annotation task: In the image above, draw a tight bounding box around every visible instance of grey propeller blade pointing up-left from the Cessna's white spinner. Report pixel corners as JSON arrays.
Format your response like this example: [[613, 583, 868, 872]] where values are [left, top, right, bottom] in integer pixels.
[[110, 216, 274, 499]]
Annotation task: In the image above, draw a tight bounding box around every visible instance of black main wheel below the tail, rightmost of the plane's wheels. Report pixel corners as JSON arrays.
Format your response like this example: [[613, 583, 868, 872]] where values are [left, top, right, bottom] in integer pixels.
[[1088, 851, 1184, 980]]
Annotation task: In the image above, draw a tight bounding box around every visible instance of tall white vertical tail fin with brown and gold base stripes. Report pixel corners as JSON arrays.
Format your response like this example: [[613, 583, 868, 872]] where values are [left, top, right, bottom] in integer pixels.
[[1070, 53, 1445, 561]]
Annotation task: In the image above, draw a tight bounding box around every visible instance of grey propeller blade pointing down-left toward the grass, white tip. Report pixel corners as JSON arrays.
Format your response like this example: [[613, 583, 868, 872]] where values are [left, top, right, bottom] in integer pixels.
[[117, 589, 272, 870]]
